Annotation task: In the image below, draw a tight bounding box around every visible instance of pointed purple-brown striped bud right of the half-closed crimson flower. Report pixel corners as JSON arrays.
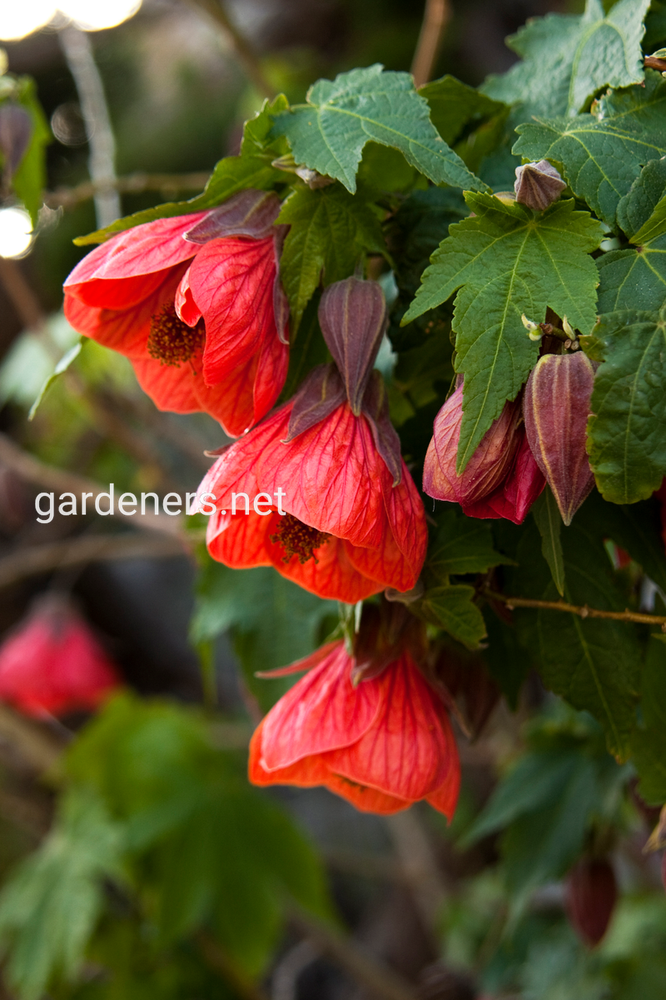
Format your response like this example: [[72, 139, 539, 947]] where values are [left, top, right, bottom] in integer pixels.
[[523, 351, 594, 524]]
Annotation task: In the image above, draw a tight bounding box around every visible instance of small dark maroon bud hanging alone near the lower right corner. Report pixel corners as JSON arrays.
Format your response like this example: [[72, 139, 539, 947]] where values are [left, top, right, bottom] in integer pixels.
[[566, 859, 617, 948]]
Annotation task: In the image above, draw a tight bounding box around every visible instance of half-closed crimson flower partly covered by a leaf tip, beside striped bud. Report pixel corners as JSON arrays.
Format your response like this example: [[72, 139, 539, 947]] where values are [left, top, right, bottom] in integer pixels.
[[423, 385, 546, 524]]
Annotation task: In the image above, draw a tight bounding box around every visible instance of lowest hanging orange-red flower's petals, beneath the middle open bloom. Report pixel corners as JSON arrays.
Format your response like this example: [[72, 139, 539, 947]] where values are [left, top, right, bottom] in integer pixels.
[[249, 642, 460, 819]]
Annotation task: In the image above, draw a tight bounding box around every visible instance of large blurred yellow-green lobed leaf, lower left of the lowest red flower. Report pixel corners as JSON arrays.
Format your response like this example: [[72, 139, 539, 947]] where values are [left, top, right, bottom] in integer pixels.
[[67, 696, 330, 975]]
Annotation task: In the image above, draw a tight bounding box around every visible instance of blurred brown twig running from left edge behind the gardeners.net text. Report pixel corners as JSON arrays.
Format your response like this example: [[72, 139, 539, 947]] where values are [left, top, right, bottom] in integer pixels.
[[0, 434, 187, 542]]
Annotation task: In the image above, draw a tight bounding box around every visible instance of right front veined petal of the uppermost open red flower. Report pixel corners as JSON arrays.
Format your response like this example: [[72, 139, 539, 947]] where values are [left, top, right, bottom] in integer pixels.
[[189, 236, 277, 385]]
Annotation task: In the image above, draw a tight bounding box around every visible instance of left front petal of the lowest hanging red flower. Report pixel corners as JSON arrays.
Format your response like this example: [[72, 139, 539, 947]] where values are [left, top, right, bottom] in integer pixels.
[[255, 641, 380, 771]]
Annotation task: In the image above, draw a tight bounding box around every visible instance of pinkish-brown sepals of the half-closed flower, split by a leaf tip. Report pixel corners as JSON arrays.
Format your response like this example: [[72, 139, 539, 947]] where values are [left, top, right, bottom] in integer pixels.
[[423, 386, 520, 507]]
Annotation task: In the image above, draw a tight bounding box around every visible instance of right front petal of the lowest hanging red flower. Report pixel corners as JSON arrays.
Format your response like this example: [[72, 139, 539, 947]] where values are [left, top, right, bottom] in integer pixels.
[[330, 653, 457, 801]]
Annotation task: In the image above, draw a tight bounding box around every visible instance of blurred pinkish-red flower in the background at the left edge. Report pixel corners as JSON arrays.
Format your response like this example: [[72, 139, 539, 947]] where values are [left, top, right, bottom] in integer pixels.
[[0, 595, 120, 717]]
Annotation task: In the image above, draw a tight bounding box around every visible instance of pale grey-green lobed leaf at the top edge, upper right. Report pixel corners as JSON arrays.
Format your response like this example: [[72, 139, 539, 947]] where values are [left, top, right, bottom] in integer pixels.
[[482, 0, 650, 117]]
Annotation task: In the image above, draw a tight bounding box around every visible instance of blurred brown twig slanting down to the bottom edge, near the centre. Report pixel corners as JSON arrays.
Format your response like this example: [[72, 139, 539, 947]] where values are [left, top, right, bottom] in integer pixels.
[[289, 906, 416, 1000]]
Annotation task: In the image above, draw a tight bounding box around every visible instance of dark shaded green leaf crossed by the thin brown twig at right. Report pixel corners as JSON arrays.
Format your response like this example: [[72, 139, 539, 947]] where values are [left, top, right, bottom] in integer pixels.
[[507, 519, 641, 759]]
